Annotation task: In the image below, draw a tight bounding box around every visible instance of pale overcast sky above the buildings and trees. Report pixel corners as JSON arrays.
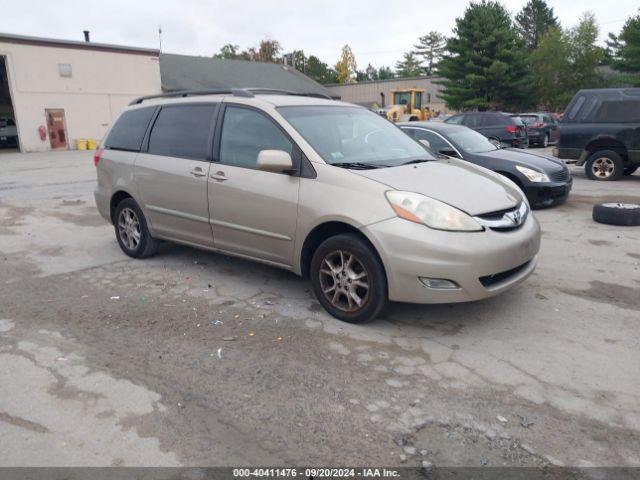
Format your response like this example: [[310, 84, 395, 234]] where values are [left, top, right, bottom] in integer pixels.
[[0, 0, 640, 69]]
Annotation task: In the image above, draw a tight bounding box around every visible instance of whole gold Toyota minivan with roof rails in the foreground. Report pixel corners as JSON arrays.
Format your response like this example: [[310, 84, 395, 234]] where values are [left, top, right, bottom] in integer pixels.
[[94, 89, 540, 322]]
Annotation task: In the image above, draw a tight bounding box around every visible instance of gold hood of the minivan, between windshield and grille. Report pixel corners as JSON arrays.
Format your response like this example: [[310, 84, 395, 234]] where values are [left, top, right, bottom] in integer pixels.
[[351, 159, 523, 215]]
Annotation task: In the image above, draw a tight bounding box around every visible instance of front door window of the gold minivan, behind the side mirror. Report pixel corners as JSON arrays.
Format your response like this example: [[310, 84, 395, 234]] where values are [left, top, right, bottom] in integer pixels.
[[220, 106, 293, 168]]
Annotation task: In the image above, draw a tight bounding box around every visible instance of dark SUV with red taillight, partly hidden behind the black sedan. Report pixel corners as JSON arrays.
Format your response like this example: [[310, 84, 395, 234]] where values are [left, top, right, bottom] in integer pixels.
[[445, 112, 529, 148]]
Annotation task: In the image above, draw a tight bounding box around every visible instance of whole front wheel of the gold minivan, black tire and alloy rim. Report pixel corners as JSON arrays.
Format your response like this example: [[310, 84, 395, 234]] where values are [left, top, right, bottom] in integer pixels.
[[311, 233, 387, 323]]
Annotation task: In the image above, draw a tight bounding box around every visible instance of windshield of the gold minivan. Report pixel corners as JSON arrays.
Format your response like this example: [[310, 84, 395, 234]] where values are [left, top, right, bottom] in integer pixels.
[[278, 105, 435, 168]]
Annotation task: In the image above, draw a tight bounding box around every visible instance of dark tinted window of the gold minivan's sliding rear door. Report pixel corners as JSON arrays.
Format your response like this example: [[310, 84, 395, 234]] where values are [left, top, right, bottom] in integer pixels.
[[149, 105, 216, 160]]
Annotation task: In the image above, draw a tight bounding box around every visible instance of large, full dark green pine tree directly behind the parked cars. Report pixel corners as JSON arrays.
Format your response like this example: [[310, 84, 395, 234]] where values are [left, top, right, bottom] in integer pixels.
[[438, 0, 532, 110]]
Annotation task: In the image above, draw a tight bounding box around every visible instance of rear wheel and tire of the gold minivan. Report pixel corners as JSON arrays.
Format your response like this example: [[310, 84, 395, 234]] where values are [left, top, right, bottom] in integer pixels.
[[113, 198, 159, 258]]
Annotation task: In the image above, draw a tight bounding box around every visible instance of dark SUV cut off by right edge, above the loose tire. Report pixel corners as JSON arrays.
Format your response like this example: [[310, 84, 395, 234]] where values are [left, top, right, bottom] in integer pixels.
[[553, 88, 640, 180]]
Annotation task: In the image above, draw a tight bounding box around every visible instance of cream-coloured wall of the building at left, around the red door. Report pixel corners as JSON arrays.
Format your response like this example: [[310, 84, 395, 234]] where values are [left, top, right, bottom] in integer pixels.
[[0, 40, 161, 151]]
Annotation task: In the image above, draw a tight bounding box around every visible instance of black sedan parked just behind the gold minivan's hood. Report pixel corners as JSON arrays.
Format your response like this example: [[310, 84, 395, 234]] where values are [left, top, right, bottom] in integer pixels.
[[399, 122, 572, 208]]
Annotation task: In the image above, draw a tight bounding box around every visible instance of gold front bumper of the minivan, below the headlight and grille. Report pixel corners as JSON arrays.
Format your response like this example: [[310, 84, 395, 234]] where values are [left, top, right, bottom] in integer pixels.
[[362, 213, 540, 303]]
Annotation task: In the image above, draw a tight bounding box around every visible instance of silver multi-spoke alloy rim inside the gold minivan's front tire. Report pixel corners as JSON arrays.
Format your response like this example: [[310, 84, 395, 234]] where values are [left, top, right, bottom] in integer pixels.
[[319, 250, 370, 312]]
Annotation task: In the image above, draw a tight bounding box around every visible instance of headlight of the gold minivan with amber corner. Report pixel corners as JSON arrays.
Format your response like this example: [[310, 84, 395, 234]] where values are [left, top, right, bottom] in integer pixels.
[[386, 190, 482, 232]]
